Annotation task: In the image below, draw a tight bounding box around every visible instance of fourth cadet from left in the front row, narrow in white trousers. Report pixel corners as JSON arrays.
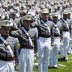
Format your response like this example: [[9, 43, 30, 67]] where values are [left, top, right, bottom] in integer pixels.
[[49, 12, 60, 68]]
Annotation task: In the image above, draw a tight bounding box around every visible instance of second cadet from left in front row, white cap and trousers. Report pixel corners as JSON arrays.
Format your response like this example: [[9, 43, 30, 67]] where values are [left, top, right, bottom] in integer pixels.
[[19, 15, 36, 72]]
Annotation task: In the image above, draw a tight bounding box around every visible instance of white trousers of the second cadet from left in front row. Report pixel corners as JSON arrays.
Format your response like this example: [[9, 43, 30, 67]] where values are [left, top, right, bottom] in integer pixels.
[[19, 49, 34, 72]]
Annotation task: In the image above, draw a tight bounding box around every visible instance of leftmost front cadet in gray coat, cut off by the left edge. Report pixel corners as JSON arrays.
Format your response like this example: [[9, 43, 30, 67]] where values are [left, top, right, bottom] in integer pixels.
[[0, 20, 18, 72]]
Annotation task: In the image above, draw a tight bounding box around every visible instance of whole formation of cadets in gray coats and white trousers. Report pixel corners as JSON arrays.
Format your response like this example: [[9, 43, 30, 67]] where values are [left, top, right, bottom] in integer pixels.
[[0, 1, 72, 72]]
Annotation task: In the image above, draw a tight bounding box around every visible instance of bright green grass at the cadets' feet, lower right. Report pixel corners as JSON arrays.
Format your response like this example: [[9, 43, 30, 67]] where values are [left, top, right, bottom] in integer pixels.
[[33, 54, 72, 72]]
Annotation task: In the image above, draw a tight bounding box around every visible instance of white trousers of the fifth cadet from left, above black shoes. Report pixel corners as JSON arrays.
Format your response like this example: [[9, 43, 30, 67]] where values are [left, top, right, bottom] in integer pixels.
[[60, 32, 70, 58]]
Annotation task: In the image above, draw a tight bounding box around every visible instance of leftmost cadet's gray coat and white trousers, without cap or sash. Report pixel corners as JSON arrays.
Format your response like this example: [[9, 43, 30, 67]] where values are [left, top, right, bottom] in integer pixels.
[[0, 35, 18, 72]]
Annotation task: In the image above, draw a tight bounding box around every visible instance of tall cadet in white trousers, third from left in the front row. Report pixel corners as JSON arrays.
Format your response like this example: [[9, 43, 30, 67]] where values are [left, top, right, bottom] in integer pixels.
[[38, 9, 51, 72]]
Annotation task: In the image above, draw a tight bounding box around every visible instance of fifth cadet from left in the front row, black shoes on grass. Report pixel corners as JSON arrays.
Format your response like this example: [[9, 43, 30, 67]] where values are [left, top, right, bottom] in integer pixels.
[[59, 10, 70, 61]]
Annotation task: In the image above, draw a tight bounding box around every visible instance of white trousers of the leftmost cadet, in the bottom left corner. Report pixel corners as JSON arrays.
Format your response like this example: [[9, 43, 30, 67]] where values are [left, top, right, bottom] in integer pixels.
[[0, 60, 15, 72]]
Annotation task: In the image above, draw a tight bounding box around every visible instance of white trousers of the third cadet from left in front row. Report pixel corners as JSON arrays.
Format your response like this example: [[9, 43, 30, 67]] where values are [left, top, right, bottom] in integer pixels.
[[38, 37, 51, 72]]
